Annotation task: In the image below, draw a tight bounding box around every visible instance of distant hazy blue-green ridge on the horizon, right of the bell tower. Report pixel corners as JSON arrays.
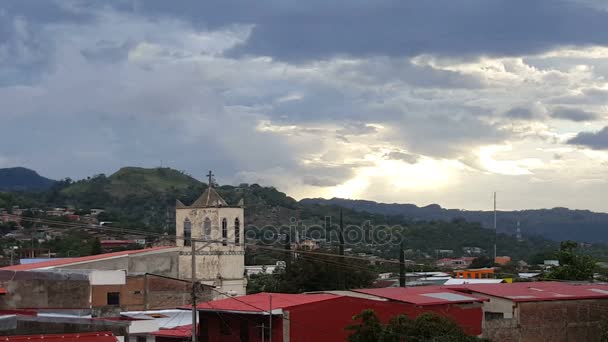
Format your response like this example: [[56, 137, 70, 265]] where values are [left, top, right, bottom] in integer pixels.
[[300, 198, 608, 243]]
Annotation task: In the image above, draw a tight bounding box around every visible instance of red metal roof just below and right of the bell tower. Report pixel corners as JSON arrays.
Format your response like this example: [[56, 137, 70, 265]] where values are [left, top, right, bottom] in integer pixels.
[[194, 292, 340, 313]]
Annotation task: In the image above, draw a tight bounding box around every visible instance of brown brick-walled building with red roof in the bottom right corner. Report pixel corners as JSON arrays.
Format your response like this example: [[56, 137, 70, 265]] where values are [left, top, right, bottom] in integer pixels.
[[448, 282, 608, 342]]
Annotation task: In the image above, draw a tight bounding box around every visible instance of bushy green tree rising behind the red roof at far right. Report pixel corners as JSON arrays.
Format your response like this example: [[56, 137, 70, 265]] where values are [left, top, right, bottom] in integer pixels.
[[547, 240, 597, 280]]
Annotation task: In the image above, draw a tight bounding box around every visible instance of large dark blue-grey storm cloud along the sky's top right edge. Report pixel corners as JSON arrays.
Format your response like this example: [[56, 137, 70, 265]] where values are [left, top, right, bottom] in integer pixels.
[[123, 0, 608, 61]]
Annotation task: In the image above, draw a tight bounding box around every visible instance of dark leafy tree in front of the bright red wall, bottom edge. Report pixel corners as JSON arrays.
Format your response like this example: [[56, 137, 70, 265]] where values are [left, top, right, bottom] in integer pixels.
[[346, 309, 483, 342]]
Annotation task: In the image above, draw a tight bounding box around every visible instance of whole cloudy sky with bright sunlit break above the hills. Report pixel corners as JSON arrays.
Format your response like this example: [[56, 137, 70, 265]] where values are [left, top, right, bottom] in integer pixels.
[[0, 0, 608, 211]]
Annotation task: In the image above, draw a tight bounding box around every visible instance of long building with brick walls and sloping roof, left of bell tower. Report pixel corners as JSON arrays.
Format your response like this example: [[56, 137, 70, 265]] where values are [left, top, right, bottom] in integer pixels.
[[0, 247, 210, 317]]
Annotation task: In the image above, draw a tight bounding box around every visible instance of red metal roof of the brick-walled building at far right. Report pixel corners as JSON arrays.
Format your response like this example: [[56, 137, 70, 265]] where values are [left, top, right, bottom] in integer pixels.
[[449, 281, 608, 302]]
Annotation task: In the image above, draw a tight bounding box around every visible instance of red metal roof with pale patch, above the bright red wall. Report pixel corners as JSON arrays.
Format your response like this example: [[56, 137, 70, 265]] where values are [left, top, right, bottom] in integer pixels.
[[353, 286, 486, 305]]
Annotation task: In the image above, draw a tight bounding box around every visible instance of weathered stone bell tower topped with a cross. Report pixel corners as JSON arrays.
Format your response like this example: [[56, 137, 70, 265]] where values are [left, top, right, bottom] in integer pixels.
[[175, 171, 247, 297]]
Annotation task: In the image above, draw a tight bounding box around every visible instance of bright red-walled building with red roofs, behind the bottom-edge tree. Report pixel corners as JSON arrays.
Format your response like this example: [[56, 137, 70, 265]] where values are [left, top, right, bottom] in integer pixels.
[[190, 287, 483, 342]]
